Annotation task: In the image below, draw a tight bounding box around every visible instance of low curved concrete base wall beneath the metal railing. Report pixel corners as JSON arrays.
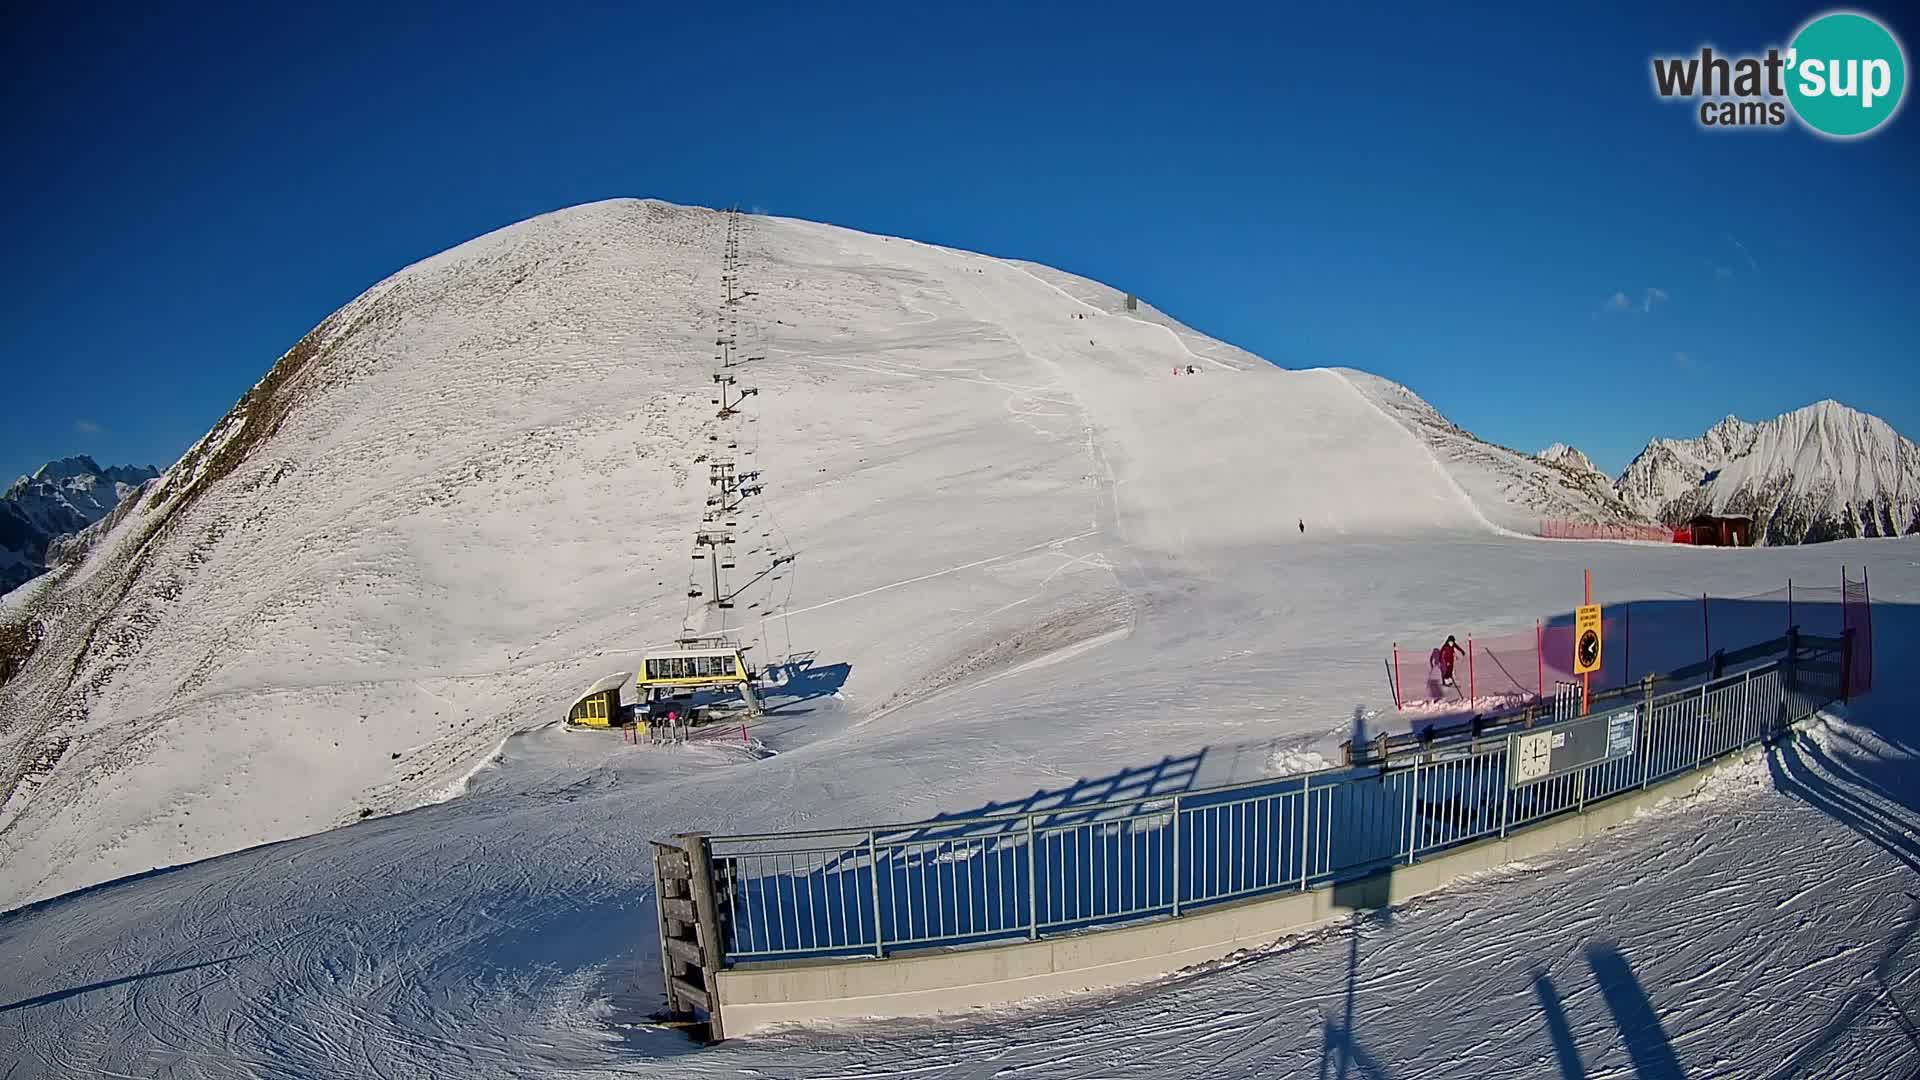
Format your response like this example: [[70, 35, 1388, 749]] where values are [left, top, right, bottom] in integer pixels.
[[716, 748, 1763, 1036]]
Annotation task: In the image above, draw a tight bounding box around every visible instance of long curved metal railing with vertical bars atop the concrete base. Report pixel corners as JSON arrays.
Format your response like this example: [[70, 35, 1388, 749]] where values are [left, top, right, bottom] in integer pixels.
[[679, 634, 1853, 965]]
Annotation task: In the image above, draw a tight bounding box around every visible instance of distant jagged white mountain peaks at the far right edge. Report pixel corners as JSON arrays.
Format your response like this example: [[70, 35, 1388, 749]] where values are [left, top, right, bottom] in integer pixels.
[[1619, 402, 1920, 544]]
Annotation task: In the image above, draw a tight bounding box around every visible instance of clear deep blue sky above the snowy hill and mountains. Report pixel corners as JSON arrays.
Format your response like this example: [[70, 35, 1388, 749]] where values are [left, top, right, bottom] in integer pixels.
[[0, 2, 1920, 477]]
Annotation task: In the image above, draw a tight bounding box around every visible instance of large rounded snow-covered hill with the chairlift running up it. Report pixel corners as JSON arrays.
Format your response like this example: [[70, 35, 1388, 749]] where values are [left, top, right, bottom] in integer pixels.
[[0, 200, 1635, 905]]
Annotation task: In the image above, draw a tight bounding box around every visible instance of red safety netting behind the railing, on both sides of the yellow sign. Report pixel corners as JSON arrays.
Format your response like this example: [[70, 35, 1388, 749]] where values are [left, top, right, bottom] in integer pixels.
[[1388, 569, 1874, 713]]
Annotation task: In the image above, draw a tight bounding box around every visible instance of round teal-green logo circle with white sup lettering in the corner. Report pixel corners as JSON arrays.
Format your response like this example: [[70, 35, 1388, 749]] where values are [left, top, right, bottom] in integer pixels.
[[1788, 12, 1907, 138]]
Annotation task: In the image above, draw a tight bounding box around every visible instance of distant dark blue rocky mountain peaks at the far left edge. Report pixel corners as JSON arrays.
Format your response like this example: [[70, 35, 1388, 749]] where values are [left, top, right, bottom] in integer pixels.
[[0, 455, 159, 594]]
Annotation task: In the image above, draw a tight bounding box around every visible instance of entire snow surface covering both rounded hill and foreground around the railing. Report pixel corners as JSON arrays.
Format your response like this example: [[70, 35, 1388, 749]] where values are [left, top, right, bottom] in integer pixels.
[[0, 204, 1920, 1078]]
